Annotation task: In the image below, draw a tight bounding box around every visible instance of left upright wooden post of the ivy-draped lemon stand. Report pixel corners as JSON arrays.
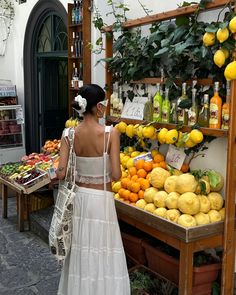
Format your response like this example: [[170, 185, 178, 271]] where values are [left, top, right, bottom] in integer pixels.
[[105, 32, 113, 115]]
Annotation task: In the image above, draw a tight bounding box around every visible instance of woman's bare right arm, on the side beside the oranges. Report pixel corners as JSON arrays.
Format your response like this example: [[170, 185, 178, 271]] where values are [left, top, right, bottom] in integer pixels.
[[110, 128, 121, 181]]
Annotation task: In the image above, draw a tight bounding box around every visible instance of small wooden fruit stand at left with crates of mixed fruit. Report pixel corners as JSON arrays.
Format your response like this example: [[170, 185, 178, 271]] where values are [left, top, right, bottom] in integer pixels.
[[0, 139, 60, 231]]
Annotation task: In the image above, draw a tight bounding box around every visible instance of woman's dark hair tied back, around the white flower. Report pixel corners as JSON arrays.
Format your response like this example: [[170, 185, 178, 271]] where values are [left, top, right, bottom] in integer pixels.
[[72, 84, 105, 114]]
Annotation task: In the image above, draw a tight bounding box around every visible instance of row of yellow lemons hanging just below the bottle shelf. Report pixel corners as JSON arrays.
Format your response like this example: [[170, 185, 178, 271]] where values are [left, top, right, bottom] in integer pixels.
[[116, 121, 204, 148]]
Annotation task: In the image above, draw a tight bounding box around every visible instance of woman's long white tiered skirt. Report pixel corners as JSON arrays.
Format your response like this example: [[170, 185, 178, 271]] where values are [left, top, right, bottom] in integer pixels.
[[58, 187, 130, 295]]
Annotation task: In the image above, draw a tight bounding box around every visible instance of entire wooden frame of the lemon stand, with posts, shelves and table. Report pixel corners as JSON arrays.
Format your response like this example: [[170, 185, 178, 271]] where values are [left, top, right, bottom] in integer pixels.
[[104, 0, 236, 295]]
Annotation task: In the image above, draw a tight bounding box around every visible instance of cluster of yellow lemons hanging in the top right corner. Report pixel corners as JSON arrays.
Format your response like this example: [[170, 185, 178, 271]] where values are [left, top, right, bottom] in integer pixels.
[[203, 16, 236, 80]]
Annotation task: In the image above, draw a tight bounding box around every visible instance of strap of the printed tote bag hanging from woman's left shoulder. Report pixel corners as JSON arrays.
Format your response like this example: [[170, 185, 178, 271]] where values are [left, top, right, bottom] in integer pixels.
[[65, 128, 75, 185]]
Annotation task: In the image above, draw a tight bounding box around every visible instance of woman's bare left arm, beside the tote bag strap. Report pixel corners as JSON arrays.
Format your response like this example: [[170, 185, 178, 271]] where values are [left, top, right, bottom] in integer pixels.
[[56, 137, 69, 180]]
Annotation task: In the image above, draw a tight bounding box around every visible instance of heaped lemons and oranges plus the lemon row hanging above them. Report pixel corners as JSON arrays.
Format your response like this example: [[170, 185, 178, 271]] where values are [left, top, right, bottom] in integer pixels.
[[112, 122, 225, 227]]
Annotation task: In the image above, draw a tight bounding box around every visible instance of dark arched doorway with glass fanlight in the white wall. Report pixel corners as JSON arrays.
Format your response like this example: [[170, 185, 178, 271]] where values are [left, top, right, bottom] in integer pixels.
[[24, 0, 68, 153]]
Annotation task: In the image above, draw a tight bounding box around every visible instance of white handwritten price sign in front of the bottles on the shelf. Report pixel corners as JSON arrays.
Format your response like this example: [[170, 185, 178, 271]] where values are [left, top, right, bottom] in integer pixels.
[[121, 101, 144, 120]]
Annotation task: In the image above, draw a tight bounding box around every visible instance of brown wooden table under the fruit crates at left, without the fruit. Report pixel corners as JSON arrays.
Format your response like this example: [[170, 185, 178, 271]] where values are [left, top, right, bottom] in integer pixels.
[[0, 177, 50, 231]]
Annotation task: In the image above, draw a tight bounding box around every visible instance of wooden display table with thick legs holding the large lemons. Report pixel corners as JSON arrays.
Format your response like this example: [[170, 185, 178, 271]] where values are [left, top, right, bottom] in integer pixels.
[[115, 200, 234, 295]]
